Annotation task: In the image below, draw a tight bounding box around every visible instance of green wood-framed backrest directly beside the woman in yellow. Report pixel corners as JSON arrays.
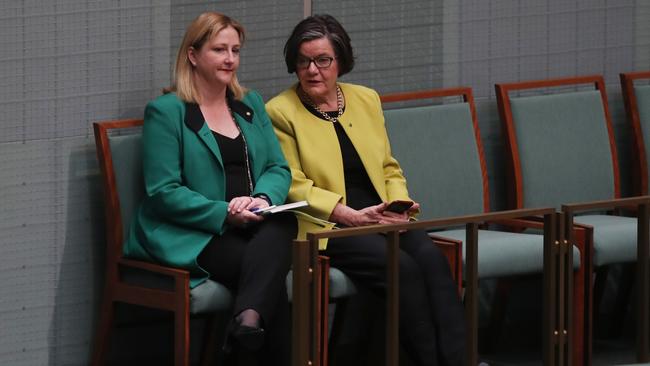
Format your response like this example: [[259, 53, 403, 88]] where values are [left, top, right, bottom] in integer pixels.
[[381, 88, 489, 219]]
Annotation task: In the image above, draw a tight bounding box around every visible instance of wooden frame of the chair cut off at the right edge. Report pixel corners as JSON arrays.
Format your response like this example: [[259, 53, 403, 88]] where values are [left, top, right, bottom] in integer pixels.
[[620, 71, 650, 196]]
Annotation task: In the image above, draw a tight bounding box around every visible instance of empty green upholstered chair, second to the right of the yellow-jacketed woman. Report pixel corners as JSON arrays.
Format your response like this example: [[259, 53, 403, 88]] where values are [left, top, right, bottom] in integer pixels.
[[496, 76, 637, 365]]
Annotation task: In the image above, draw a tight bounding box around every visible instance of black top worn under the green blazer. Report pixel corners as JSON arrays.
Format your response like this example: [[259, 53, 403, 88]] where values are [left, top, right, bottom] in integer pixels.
[[212, 131, 251, 201]]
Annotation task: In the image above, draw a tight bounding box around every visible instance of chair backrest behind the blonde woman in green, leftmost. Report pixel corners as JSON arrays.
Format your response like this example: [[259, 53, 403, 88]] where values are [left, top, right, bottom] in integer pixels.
[[93, 119, 144, 262]]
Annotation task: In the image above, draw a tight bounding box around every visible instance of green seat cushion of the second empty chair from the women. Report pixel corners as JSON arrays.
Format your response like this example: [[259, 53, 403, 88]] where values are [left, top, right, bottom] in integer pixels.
[[573, 215, 637, 266]]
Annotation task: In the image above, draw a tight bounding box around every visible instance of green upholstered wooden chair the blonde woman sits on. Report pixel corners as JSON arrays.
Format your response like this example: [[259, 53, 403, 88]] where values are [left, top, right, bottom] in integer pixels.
[[92, 120, 232, 366]]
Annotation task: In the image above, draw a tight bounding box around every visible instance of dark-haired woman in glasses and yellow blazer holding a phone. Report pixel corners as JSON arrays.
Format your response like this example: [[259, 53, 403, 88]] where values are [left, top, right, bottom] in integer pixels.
[[266, 15, 465, 366]]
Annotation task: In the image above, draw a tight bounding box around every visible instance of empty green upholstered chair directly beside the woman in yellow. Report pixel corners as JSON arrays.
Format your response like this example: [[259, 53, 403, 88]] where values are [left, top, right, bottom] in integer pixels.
[[382, 88, 580, 364]]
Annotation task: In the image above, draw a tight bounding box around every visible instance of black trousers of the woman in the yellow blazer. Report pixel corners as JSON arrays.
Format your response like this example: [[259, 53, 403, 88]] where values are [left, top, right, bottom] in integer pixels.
[[324, 230, 465, 366]]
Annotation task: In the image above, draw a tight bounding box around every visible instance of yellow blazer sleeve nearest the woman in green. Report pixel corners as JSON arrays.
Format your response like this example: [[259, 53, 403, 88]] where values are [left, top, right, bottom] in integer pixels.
[[267, 104, 343, 220]]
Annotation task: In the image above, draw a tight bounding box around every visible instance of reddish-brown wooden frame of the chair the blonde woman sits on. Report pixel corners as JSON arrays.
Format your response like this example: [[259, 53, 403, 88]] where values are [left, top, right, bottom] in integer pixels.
[[91, 119, 216, 366]]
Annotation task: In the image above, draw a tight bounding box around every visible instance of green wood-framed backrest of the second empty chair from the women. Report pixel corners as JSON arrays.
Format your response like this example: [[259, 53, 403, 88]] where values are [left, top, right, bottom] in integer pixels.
[[496, 76, 620, 208]]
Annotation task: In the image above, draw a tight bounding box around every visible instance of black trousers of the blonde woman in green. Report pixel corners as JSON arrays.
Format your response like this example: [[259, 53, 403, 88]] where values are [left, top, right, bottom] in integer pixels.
[[198, 213, 297, 365]]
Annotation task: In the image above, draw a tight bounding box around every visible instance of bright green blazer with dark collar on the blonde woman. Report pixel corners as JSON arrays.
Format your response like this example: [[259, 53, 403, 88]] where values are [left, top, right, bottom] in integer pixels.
[[124, 91, 291, 287]]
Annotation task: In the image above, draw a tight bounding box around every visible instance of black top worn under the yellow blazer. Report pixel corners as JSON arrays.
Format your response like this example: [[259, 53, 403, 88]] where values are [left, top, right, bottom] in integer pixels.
[[303, 103, 381, 210]]
